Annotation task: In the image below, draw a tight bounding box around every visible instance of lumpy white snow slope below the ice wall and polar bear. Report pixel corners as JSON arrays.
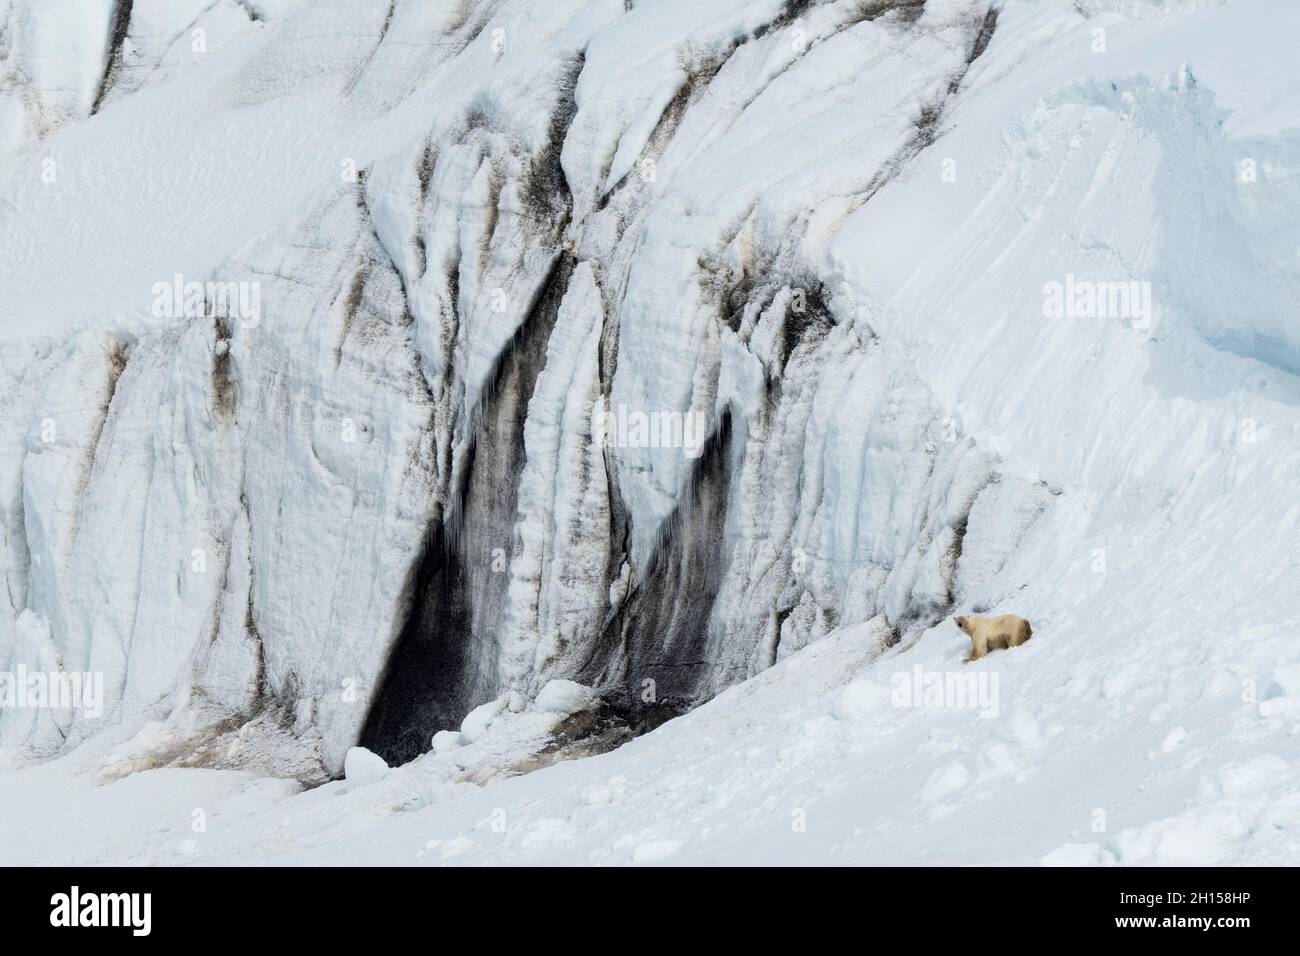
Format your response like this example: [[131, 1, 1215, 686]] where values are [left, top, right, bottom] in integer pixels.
[[0, 616, 1300, 865]]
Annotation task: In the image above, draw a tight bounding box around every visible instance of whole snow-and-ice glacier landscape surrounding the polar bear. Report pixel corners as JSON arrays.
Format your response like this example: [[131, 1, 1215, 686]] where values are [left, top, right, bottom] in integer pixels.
[[0, 0, 1300, 865]]
